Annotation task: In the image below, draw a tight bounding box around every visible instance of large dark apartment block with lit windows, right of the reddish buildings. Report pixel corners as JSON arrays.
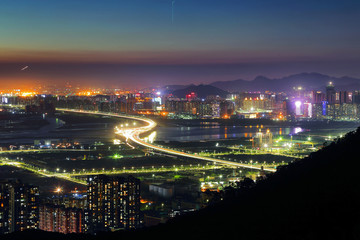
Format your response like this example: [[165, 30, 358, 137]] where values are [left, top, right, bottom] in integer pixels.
[[85, 175, 140, 233]]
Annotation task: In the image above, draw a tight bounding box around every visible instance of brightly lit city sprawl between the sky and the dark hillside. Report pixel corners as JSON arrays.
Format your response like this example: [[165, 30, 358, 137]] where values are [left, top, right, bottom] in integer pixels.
[[0, 78, 360, 234]]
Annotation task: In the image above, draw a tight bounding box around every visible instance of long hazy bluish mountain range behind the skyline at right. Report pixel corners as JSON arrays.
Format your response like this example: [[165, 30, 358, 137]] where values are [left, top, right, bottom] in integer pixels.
[[210, 73, 360, 92]]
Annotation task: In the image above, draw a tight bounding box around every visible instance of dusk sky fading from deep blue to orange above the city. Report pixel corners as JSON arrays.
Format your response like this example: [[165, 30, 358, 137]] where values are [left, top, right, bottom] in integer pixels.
[[0, 0, 360, 88]]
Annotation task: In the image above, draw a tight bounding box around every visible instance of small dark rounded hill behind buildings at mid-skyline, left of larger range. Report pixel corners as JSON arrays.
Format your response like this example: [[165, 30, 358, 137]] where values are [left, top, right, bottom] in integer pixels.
[[172, 84, 229, 98]]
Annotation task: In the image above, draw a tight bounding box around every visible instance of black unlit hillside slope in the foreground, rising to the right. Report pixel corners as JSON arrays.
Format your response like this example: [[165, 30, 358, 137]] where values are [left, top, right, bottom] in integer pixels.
[[5, 126, 360, 239]]
